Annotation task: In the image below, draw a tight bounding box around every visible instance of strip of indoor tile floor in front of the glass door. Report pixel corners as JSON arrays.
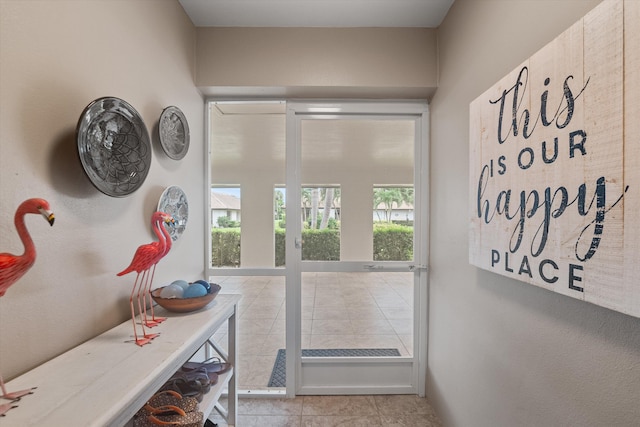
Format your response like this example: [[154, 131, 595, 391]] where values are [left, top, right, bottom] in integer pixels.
[[209, 395, 442, 427]]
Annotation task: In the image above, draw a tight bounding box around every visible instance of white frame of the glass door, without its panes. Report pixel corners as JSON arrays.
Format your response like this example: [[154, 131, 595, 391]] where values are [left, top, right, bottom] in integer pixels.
[[285, 101, 429, 397]]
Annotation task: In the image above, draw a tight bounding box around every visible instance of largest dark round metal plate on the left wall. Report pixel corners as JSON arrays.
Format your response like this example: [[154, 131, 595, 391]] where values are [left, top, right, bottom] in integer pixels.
[[76, 97, 151, 197]]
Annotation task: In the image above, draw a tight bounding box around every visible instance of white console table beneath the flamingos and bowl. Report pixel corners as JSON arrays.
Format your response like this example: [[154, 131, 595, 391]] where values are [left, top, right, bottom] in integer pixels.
[[0, 294, 240, 427]]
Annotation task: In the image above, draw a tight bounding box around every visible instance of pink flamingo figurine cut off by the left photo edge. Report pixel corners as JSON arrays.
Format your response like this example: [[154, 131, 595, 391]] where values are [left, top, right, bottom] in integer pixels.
[[0, 199, 55, 416]]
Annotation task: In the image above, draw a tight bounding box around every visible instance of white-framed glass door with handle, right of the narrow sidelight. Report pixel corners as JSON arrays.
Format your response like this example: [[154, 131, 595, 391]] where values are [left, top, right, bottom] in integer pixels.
[[286, 103, 428, 395]]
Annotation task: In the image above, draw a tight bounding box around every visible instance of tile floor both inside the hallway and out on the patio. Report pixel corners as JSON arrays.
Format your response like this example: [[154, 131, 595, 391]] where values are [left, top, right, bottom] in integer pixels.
[[204, 273, 442, 427]]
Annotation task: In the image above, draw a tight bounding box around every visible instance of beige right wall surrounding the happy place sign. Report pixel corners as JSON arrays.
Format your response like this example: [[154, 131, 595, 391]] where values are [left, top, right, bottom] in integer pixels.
[[427, 0, 640, 427]]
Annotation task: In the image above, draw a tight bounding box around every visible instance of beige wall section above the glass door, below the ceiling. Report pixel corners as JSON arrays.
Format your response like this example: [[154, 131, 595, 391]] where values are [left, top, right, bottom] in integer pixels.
[[196, 27, 437, 99]]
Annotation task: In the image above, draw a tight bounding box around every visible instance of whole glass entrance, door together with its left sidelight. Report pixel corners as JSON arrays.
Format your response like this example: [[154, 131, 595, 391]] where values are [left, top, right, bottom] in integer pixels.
[[206, 101, 428, 396]]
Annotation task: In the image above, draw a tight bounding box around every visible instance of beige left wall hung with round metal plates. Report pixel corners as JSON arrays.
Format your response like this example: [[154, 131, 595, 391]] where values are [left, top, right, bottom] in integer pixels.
[[0, 0, 204, 385]]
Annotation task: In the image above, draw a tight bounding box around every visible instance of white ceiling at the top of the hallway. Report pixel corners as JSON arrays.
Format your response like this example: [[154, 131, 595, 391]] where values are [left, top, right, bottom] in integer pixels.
[[179, 0, 454, 28]]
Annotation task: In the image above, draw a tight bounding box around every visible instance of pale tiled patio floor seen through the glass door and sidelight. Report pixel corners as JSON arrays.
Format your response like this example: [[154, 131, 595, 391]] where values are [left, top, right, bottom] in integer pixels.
[[210, 272, 413, 392]]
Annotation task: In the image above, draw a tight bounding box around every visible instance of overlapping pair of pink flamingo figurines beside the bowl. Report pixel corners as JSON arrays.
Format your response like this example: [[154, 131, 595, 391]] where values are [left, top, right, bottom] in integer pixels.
[[117, 212, 174, 347]]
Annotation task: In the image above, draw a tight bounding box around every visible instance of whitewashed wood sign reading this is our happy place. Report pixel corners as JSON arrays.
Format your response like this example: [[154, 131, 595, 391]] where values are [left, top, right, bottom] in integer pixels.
[[469, 0, 640, 317]]
